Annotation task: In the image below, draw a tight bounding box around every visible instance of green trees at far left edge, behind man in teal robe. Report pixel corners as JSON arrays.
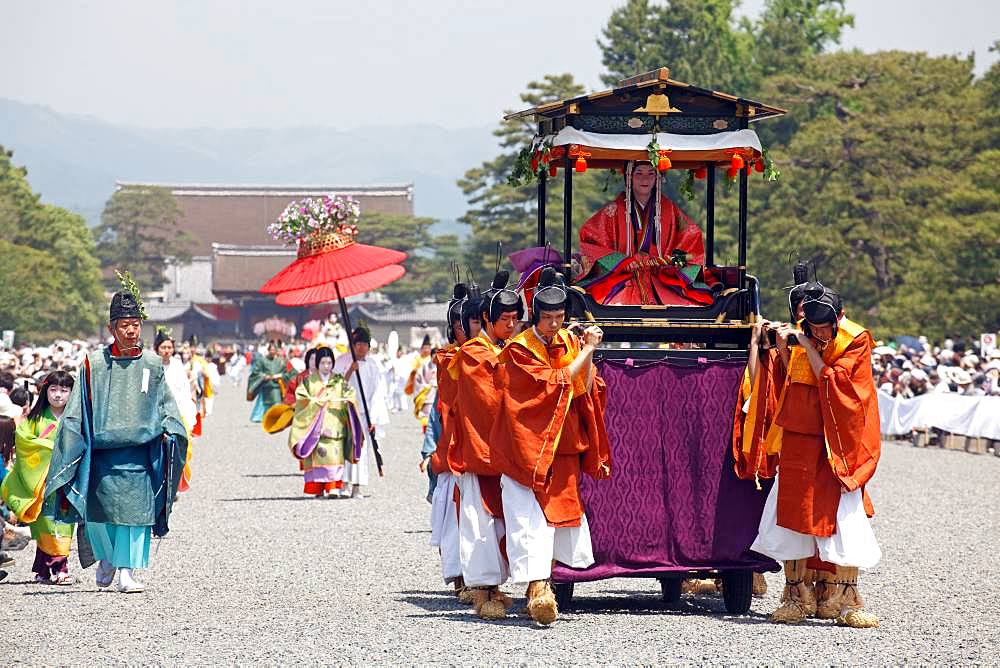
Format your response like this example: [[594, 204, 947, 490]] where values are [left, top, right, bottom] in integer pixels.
[[0, 147, 103, 340]]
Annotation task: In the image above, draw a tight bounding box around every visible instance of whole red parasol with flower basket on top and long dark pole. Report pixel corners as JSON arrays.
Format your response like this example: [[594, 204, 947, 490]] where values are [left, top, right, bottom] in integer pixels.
[[260, 195, 414, 476]]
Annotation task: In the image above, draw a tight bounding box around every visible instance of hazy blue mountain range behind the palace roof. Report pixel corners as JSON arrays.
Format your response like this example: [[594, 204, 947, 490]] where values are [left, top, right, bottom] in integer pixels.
[[0, 98, 497, 226]]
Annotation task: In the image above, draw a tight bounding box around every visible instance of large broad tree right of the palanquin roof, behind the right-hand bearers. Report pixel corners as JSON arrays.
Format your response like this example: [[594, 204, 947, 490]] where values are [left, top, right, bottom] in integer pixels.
[[750, 52, 988, 340]]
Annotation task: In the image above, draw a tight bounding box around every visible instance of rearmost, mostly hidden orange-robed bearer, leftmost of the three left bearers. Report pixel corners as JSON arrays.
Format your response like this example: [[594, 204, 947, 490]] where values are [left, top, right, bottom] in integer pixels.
[[421, 283, 479, 603]]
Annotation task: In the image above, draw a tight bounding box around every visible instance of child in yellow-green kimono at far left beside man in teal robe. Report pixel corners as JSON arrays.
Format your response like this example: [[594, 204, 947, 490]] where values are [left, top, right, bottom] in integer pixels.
[[0, 371, 75, 585]]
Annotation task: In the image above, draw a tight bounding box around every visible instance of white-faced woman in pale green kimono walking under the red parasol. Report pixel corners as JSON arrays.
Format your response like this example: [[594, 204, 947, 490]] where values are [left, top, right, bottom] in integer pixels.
[[288, 348, 362, 498]]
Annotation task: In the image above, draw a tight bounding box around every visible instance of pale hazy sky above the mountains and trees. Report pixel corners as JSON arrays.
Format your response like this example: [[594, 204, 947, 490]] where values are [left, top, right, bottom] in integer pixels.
[[0, 0, 1000, 130]]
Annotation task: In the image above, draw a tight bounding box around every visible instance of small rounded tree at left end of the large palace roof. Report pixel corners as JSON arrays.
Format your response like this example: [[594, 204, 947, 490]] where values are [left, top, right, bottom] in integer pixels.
[[94, 186, 192, 291]]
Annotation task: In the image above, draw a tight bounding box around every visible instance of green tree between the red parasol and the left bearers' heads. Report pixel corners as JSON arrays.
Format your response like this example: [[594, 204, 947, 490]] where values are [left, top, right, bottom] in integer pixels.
[[358, 213, 460, 304]]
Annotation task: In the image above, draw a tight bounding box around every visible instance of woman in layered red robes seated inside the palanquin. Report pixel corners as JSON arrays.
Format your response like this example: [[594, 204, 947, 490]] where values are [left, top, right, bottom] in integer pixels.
[[579, 161, 713, 305]]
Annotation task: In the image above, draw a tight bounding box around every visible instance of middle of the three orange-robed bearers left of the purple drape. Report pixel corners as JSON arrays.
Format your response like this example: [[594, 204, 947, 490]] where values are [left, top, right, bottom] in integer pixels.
[[448, 271, 524, 619]]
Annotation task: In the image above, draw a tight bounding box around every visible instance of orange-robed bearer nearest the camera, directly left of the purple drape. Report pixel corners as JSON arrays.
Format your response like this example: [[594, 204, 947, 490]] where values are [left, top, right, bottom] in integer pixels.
[[490, 267, 611, 625]]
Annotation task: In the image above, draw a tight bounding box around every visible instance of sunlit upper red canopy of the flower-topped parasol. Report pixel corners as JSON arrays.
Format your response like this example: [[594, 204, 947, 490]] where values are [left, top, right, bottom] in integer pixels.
[[260, 233, 406, 294]]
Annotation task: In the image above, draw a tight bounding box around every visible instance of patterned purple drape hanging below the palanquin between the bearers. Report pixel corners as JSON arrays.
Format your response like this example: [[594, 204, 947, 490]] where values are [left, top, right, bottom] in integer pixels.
[[552, 359, 777, 582]]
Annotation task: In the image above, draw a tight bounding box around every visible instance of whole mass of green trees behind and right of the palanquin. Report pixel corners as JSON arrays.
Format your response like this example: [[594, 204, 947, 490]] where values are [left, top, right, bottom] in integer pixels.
[[460, 0, 1000, 337]]
